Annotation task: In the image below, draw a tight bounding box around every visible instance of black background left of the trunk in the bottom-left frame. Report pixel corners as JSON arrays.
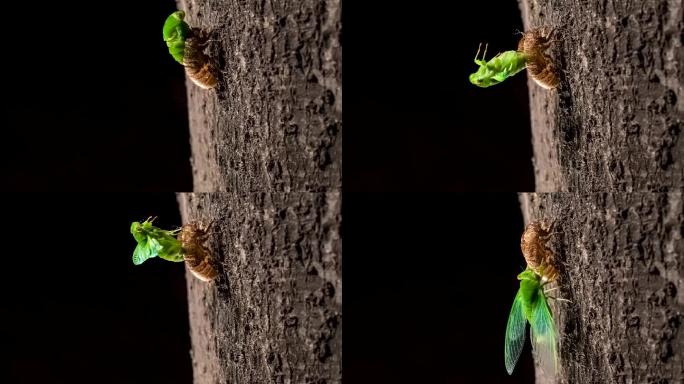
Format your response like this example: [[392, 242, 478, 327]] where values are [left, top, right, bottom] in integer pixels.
[[0, 193, 192, 384]]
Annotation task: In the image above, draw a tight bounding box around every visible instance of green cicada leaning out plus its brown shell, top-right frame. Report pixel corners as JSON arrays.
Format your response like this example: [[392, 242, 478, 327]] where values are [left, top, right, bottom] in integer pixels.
[[469, 27, 558, 89]]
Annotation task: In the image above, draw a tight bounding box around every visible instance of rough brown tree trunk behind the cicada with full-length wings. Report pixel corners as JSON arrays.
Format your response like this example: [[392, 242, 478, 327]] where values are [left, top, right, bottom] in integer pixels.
[[520, 192, 684, 383]]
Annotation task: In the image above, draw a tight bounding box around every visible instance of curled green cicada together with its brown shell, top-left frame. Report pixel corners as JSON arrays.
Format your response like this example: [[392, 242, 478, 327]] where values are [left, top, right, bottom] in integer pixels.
[[162, 11, 217, 89]]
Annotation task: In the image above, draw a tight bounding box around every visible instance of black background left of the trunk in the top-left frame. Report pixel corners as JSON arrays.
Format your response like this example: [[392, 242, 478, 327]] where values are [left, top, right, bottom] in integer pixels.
[[0, 0, 192, 191]]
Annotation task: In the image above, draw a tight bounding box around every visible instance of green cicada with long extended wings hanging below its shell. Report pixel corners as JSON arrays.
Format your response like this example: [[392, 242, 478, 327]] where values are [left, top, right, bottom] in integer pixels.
[[504, 268, 558, 377]]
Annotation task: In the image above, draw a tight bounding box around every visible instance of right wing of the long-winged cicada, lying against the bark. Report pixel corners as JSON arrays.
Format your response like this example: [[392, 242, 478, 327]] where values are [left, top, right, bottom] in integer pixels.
[[530, 292, 558, 377]]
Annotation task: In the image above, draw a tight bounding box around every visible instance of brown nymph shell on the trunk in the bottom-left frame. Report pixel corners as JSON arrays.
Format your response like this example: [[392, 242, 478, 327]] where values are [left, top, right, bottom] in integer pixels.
[[177, 223, 218, 281]]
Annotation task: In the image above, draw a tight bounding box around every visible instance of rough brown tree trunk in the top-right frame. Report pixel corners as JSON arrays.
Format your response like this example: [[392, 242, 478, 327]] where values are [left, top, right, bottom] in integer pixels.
[[519, 0, 684, 192]]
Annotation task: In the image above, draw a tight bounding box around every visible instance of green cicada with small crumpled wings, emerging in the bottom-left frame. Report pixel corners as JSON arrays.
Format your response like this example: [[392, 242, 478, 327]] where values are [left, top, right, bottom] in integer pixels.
[[131, 219, 183, 265]]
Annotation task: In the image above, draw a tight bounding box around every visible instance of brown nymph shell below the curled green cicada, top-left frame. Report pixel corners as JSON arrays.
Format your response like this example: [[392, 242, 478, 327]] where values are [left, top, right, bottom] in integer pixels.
[[183, 28, 217, 89]]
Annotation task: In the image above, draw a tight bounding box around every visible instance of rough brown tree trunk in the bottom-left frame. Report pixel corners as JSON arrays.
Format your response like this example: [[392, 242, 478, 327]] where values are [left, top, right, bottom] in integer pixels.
[[178, 192, 342, 384]]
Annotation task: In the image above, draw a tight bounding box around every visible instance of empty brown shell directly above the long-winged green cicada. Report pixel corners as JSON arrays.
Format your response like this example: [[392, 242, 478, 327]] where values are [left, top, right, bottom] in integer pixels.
[[520, 221, 558, 281]]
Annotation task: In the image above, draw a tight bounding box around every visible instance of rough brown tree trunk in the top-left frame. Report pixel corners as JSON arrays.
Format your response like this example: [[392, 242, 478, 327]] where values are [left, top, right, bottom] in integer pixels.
[[178, 0, 342, 193]]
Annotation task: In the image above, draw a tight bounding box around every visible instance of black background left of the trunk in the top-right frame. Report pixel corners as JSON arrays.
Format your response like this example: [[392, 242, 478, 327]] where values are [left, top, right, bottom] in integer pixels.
[[343, 0, 534, 191]]
